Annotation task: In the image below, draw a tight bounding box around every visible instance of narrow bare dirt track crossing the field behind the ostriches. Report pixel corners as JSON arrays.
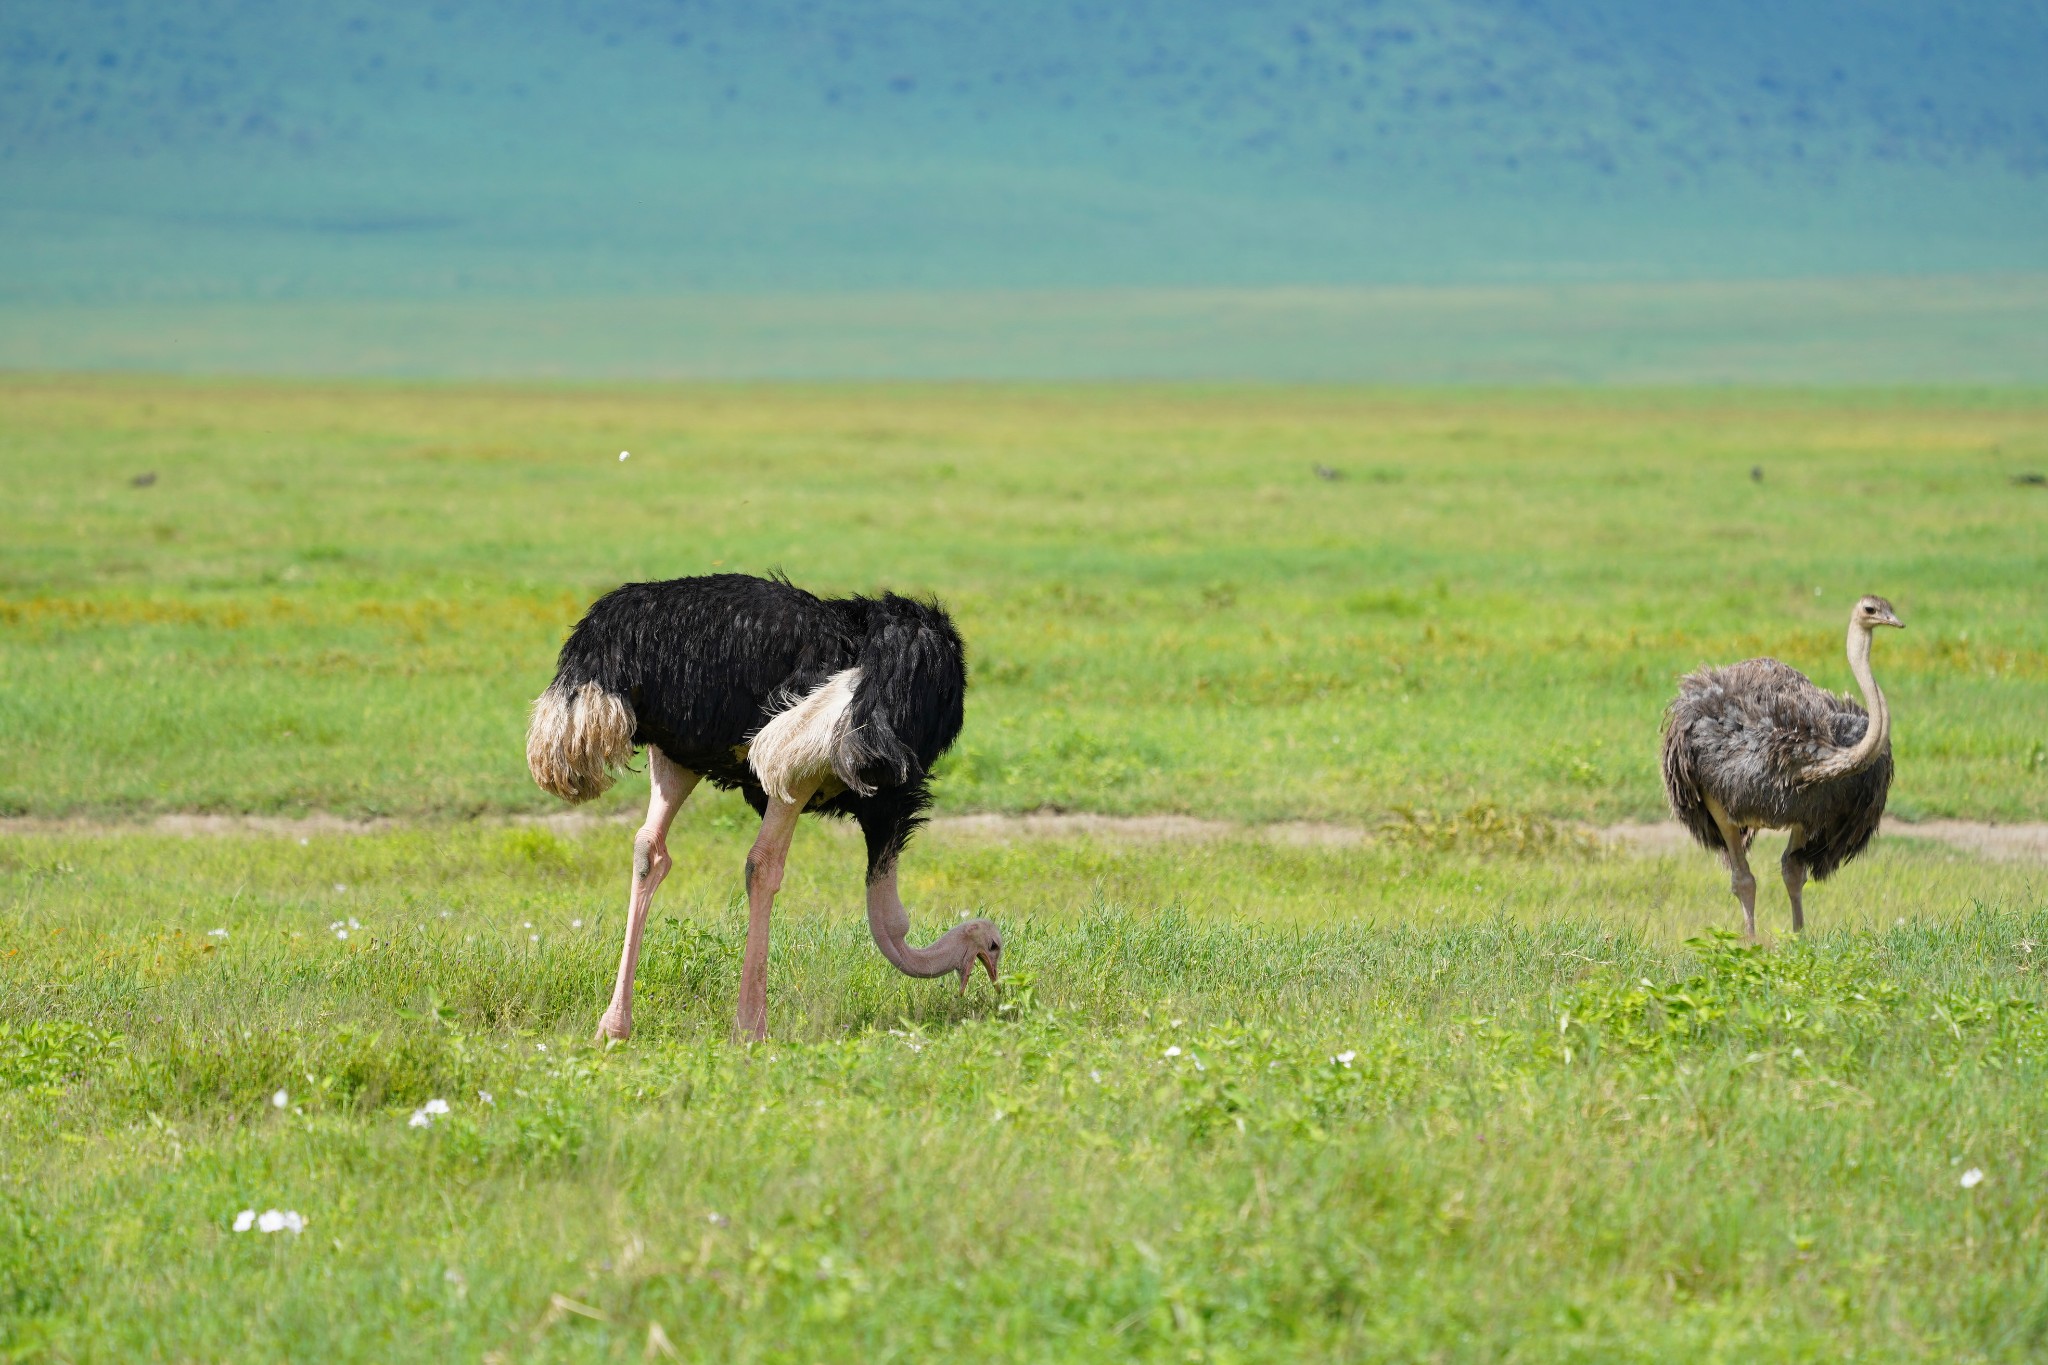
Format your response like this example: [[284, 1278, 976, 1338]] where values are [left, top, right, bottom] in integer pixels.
[[0, 810, 2048, 862]]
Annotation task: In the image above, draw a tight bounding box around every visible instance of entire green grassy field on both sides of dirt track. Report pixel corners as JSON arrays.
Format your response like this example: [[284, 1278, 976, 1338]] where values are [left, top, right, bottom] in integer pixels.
[[0, 377, 2048, 1361]]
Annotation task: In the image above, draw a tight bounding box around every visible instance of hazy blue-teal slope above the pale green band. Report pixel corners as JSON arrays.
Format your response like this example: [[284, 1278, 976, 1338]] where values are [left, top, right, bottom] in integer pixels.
[[0, 0, 2048, 299]]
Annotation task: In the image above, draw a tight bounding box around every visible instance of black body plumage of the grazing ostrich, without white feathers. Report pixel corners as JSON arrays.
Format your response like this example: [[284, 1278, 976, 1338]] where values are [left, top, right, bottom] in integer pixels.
[[555, 573, 967, 876]]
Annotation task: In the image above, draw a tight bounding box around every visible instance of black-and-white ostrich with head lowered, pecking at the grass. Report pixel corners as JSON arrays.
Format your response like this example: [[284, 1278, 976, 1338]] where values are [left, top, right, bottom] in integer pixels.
[[526, 573, 1004, 1040]]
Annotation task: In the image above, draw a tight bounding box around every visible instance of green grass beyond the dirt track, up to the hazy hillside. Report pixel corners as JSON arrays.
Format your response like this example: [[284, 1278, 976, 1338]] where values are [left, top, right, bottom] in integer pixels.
[[0, 377, 2048, 821]]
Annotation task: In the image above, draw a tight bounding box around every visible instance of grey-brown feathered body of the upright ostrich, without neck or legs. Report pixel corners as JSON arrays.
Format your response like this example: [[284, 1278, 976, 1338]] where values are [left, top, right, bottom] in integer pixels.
[[1663, 659, 1892, 880]]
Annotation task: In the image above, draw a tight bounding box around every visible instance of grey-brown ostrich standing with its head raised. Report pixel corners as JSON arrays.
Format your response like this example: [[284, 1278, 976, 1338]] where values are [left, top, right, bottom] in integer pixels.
[[1663, 598, 1905, 937]]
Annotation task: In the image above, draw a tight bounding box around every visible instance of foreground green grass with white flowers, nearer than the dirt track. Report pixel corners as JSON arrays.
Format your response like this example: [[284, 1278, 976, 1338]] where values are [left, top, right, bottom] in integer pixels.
[[0, 818, 2048, 1361]]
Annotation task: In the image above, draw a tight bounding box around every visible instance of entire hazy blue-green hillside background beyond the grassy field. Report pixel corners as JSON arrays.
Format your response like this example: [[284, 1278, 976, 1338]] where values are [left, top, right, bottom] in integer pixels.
[[0, 0, 2048, 383]]
